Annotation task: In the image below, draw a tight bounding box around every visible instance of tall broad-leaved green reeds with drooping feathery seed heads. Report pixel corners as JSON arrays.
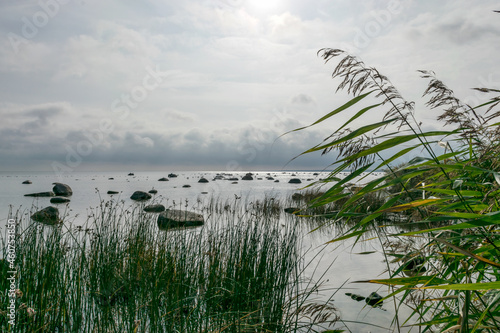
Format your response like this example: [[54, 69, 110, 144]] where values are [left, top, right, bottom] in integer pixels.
[[285, 49, 500, 333]]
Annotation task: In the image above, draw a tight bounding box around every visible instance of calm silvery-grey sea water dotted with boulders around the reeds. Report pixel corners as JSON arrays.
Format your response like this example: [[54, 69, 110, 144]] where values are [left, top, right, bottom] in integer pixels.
[[0, 170, 417, 332]]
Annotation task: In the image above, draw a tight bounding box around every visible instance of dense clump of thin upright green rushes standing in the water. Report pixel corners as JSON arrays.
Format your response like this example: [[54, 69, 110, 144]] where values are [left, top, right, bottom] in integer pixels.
[[0, 201, 336, 333]]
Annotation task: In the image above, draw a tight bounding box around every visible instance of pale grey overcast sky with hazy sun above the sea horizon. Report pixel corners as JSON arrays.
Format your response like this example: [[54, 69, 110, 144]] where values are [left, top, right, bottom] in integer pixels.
[[0, 0, 500, 171]]
